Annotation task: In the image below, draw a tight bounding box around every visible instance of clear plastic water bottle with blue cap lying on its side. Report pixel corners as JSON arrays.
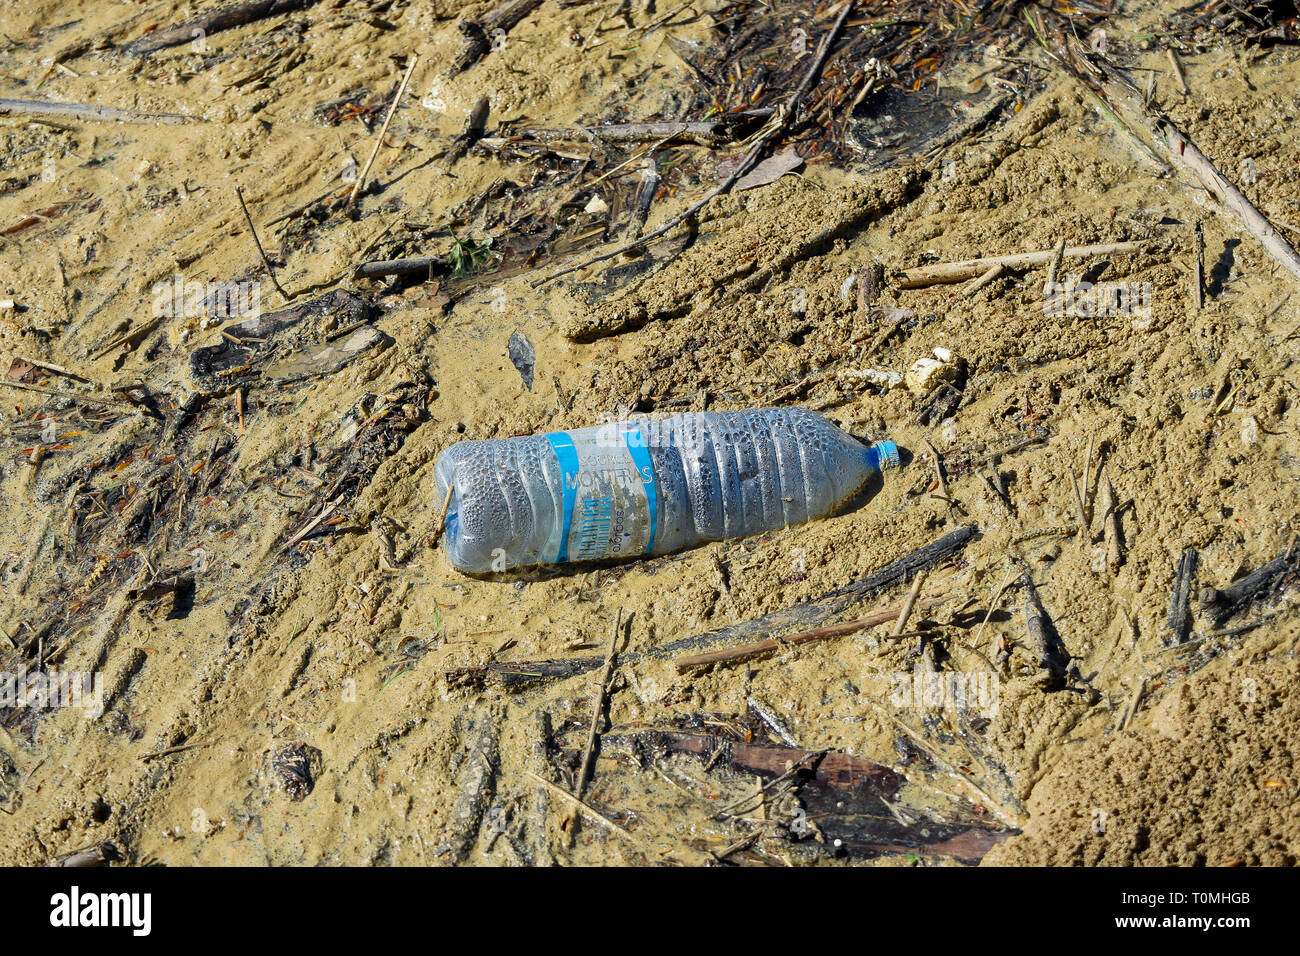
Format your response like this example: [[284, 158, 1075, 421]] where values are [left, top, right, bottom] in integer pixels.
[[434, 408, 898, 572]]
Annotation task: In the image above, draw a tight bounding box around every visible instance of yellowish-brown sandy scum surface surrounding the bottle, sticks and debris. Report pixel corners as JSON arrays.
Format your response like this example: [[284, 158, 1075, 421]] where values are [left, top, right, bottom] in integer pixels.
[[0, 0, 1300, 865]]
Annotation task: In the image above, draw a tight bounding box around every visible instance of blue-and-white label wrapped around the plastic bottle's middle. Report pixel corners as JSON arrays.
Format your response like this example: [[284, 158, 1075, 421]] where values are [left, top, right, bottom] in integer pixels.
[[546, 423, 659, 563]]
